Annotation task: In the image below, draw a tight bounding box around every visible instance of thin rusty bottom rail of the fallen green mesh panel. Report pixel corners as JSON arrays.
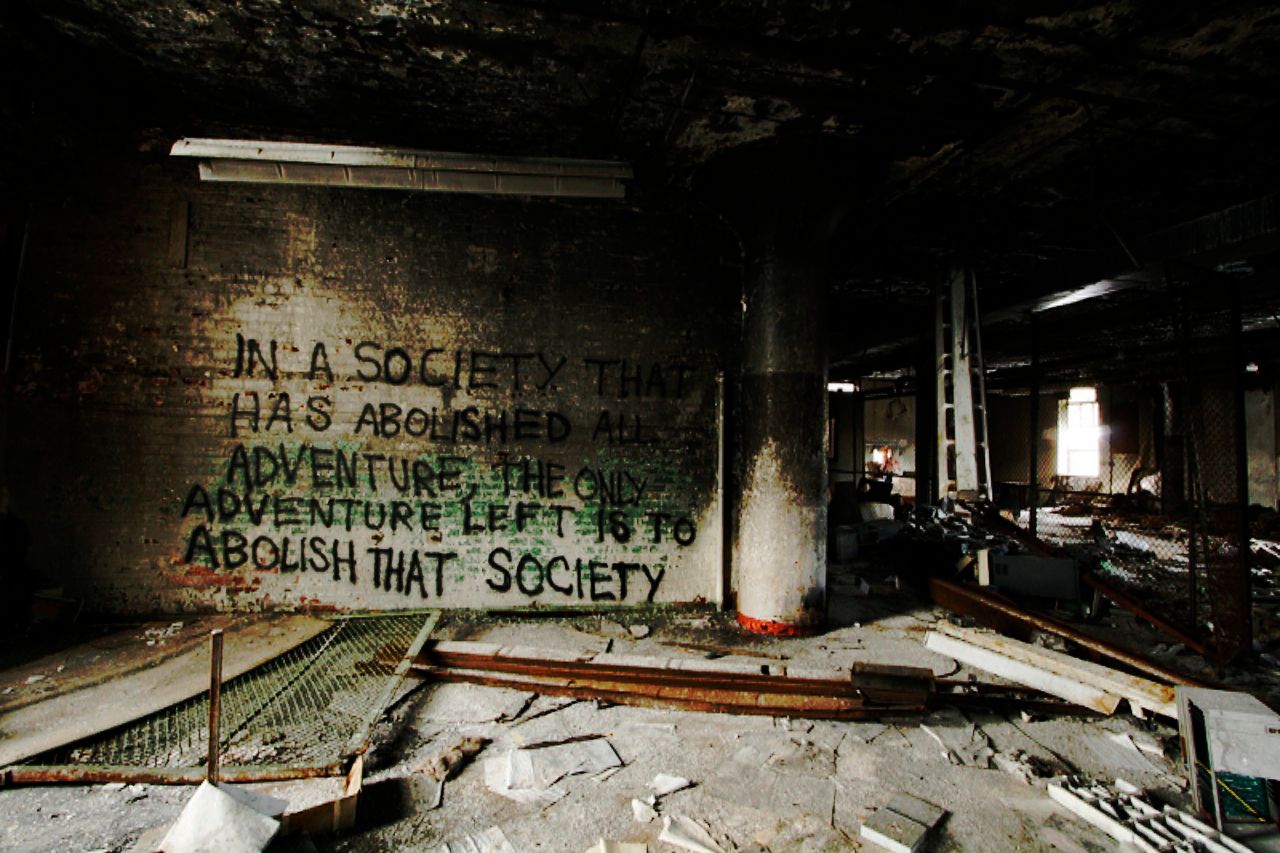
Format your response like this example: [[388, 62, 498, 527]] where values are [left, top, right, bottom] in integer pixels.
[[0, 763, 347, 788]]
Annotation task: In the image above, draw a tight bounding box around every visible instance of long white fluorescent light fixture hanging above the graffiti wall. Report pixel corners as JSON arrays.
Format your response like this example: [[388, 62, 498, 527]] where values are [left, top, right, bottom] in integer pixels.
[[169, 138, 631, 199]]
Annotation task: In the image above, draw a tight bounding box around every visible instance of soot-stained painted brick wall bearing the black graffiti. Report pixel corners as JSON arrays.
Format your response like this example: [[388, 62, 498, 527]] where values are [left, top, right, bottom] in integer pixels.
[[6, 157, 732, 612]]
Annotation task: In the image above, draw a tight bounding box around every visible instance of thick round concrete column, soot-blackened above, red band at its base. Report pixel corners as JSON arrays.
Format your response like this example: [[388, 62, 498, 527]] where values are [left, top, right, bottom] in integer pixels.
[[733, 195, 829, 635]]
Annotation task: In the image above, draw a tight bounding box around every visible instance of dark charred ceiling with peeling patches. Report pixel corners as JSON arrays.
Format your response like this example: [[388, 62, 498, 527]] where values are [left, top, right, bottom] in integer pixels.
[[0, 0, 1280, 373]]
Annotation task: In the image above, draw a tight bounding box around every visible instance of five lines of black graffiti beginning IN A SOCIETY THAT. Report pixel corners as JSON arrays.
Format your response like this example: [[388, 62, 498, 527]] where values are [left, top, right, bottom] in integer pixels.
[[180, 334, 704, 603]]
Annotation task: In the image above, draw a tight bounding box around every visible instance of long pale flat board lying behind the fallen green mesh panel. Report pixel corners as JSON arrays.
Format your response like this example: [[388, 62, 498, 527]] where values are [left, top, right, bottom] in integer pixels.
[[0, 615, 332, 772]]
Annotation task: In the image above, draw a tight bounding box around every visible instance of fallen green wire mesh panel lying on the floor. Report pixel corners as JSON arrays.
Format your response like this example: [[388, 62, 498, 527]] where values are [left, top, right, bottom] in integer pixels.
[[31, 612, 438, 767]]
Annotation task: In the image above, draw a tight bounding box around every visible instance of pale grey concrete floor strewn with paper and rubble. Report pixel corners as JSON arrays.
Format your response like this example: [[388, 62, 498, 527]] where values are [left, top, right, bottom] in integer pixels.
[[0, 566, 1275, 852]]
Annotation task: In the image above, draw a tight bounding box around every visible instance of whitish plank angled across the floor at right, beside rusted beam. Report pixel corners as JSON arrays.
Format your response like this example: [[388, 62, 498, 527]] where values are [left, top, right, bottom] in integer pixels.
[[927, 622, 1178, 720]]
